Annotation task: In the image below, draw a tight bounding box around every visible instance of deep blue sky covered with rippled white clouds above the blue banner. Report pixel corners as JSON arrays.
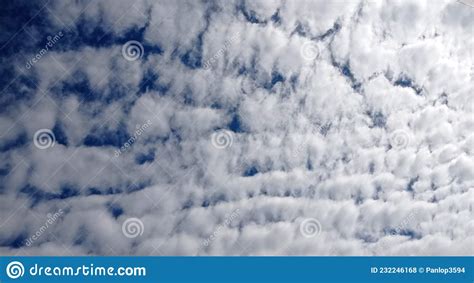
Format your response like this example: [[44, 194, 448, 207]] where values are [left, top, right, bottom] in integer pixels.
[[0, 0, 474, 255]]
